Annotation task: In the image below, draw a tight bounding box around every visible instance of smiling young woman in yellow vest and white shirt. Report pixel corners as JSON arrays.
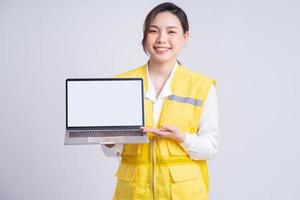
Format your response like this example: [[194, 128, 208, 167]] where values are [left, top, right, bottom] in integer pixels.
[[103, 3, 218, 200]]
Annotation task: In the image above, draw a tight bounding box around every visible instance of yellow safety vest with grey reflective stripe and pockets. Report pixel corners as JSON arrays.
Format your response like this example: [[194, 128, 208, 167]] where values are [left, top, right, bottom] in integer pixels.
[[114, 65, 215, 200]]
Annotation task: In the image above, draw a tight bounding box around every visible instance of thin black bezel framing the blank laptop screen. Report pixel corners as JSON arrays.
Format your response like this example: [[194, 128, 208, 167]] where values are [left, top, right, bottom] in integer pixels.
[[65, 78, 145, 130]]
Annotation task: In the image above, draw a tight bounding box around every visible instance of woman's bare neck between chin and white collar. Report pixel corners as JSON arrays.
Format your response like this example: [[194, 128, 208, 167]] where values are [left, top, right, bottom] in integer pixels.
[[148, 59, 176, 77]]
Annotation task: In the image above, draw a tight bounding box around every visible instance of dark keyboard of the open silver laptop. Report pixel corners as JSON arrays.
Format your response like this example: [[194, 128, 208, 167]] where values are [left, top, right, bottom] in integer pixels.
[[69, 129, 144, 137]]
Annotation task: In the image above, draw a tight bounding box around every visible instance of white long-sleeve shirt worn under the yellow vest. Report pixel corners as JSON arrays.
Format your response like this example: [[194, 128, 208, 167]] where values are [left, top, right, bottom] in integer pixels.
[[101, 63, 219, 160]]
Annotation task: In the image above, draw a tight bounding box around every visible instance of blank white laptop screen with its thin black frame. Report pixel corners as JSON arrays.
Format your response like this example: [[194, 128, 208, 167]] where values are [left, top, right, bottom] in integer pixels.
[[66, 78, 144, 128]]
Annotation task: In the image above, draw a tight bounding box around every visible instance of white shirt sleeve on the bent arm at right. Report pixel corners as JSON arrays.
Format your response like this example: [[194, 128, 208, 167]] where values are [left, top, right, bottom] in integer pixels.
[[181, 85, 219, 160]]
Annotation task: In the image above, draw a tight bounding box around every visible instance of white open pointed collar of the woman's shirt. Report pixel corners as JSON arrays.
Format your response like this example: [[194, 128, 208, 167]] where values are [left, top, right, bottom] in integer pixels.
[[145, 62, 178, 102]]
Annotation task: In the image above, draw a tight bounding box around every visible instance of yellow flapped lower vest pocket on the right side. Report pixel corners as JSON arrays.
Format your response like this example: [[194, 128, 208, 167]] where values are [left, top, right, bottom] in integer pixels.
[[169, 164, 208, 200]]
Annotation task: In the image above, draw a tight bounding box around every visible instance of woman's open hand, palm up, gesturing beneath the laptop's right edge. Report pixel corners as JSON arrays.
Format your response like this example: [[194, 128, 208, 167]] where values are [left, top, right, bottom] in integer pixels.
[[141, 125, 185, 143]]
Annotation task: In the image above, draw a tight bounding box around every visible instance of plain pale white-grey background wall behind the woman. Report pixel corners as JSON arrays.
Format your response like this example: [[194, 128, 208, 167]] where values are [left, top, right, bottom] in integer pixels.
[[0, 0, 300, 200]]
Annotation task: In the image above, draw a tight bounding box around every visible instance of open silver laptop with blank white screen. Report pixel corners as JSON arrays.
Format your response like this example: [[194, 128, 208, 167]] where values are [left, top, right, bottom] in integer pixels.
[[65, 78, 149, 144]]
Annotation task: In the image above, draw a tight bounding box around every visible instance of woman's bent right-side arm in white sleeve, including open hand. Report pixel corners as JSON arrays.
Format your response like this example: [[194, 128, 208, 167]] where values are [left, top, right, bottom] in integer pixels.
[[142, 85, 219, 160]]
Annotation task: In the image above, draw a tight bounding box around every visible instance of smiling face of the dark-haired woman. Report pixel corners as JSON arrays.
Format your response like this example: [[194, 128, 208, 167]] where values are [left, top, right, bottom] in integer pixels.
[[145, 12, 189, 63]]
